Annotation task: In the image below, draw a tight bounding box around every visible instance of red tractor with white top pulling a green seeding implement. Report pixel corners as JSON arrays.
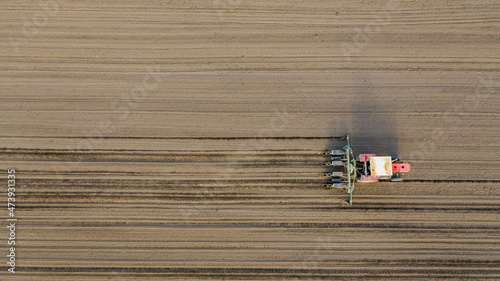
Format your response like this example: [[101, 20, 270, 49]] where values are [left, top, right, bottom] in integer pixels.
[[325, 135, 410, 205]]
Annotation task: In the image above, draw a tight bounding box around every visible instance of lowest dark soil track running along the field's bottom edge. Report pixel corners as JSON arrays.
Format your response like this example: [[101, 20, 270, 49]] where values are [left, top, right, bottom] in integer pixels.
[[6, 264, 499, 280]]
